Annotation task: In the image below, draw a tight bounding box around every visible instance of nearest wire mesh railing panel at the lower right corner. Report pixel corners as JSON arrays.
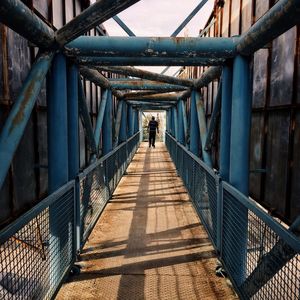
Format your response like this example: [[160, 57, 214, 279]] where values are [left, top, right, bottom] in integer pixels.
[[222, 183, 300, 299]]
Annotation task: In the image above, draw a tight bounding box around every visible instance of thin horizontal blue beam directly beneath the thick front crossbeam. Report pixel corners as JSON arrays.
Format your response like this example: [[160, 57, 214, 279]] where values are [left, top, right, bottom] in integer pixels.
[[77, 55, 226, 67]]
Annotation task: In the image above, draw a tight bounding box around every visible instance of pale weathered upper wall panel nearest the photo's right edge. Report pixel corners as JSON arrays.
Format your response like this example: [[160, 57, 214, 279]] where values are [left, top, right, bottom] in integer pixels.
[[270, 27, 297, 105]]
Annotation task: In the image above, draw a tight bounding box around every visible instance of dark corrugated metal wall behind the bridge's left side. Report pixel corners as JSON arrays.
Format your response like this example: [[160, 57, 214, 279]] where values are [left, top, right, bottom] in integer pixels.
[[0, 0, 122, 227]]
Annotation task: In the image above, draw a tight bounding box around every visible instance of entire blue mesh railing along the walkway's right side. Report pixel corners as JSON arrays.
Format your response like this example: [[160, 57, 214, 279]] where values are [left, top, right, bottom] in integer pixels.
[[166, 133, 300, 299]]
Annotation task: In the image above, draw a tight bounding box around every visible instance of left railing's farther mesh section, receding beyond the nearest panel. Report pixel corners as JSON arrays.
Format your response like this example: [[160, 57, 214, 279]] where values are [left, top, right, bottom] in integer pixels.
[[79, 133, 139, 247]]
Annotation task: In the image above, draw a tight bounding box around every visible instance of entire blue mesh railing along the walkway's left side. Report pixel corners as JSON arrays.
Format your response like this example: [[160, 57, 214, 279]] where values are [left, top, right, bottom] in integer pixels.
[[0, 132, 140, 300]]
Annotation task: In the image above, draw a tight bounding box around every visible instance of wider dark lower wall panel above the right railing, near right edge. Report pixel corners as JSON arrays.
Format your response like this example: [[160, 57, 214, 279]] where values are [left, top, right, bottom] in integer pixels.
[[265, 112, 290, 216]]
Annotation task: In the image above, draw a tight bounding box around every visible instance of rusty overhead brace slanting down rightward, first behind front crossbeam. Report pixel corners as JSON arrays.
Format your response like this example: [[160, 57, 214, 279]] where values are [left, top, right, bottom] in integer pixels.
[[97, 66, 194, 87]]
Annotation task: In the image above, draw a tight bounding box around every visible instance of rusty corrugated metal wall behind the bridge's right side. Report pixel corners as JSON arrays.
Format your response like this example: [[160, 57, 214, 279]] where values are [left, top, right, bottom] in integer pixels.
[[182, 0, 300, 222]]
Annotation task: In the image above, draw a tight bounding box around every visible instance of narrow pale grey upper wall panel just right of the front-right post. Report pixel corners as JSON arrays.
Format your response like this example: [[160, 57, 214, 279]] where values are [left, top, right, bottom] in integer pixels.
[[252, 49, 269, 107]]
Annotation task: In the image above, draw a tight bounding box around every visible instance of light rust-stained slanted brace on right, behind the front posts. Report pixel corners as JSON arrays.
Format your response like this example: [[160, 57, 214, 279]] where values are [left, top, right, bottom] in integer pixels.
[[195, 91, 212, 167]]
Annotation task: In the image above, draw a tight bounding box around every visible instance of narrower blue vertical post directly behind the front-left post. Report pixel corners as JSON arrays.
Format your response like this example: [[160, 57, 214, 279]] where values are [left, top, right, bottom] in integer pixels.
[[67, 65, 79, 180]]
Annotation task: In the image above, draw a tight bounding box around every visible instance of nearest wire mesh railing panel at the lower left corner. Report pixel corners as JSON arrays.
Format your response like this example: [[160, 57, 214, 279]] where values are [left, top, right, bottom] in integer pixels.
[[0, 182, 75, 299]]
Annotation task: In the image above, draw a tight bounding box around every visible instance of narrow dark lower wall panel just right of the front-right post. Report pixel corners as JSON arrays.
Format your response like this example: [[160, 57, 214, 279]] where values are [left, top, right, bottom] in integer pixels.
[[249, 113, 264, 199]]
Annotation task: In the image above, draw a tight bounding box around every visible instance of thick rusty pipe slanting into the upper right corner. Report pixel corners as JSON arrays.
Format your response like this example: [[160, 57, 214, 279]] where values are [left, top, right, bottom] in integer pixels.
[[237, 0, 300, 55]]
